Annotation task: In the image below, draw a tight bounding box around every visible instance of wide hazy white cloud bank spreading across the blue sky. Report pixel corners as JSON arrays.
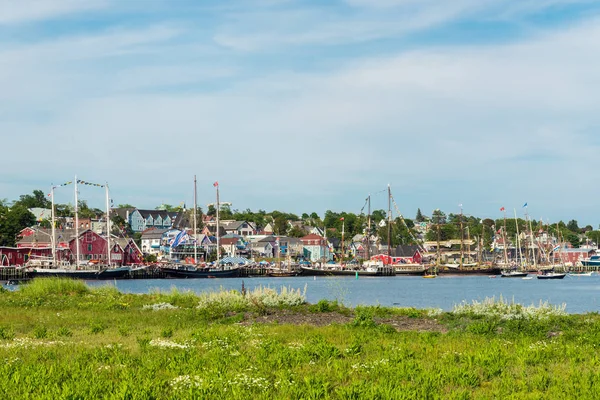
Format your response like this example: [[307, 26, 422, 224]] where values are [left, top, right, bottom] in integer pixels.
[[0, 2, 600, 220]]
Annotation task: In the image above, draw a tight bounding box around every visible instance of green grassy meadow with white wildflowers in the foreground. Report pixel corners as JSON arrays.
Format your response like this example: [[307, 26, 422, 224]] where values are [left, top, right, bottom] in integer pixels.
[[0, 279, 600, 399]]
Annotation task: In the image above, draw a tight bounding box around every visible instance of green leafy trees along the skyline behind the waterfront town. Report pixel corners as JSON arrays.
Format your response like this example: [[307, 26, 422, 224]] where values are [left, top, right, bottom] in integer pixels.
[[0, 190, 600, 247]]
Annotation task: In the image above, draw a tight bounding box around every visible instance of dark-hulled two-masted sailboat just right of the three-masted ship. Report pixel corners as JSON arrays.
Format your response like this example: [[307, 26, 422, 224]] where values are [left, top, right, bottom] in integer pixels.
[[159, 175, 240, 278]]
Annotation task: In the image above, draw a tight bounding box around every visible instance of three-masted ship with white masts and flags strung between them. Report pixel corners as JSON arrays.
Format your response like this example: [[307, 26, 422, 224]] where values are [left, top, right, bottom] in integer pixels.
[[25, 176, 130, 280]]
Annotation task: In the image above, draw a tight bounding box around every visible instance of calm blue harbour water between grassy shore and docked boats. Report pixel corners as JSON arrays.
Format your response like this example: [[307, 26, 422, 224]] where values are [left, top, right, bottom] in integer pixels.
[[71, 274, 600, 313]]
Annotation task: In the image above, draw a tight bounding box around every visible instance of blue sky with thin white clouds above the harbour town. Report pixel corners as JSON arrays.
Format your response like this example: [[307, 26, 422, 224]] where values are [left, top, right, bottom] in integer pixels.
[[0, 0, 600, 227]]
